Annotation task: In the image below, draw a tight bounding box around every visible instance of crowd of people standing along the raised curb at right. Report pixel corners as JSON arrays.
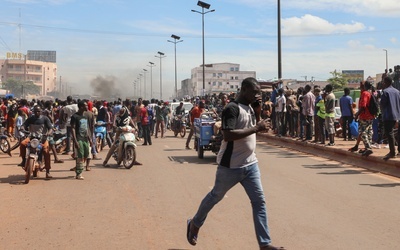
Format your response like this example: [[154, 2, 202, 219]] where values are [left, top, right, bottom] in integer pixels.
[[262, 77, 400, 160]]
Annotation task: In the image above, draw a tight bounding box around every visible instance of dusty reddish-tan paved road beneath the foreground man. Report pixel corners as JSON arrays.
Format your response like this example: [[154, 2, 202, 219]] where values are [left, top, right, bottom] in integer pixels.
[[0, 134, 400, 250]]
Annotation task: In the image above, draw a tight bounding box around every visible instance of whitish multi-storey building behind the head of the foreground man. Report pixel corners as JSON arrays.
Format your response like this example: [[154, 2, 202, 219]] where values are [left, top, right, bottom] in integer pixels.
[[188, 63, 256, 96]]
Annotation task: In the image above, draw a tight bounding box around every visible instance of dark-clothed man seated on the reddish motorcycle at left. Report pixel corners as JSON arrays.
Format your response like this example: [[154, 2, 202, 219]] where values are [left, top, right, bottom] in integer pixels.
[[18, 105, 53, 179]]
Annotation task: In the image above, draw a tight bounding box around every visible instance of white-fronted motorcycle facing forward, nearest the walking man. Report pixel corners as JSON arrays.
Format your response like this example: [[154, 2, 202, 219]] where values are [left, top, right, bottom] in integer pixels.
[[112, 126, 136, 169]]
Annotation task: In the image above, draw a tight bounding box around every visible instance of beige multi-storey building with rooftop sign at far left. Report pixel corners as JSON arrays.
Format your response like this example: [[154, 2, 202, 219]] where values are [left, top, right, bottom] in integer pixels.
[[0, 51, 57, 96]]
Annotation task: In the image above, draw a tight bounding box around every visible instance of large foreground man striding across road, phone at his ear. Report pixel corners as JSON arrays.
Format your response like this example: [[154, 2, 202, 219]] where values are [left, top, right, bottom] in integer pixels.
[[186, 78, 284, 249]]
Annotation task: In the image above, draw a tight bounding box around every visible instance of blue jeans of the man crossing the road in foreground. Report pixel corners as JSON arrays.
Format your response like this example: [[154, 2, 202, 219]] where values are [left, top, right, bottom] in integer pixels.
[[193, 163, 271, 246]]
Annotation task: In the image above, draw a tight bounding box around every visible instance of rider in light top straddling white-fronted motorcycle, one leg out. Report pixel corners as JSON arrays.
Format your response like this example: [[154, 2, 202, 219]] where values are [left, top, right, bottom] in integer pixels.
[[103, 106, 142, 167]]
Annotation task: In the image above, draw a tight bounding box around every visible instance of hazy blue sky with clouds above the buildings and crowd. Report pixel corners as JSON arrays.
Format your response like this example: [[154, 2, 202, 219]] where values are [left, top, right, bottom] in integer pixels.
[[0, 0, 400, 99]]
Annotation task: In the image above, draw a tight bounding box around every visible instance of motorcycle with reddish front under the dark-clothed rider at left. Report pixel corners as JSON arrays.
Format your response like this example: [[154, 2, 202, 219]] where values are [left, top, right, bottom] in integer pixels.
[[24, 133, 43, 184]]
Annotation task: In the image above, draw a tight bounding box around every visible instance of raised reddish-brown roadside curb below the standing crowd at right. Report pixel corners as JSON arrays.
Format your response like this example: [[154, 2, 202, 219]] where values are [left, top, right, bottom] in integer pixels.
[[257, 133, 400, 178]]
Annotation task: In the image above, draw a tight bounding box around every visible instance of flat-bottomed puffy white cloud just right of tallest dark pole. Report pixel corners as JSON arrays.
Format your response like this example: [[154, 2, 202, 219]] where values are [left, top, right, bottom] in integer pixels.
[[282, 14, 365, 36]]
